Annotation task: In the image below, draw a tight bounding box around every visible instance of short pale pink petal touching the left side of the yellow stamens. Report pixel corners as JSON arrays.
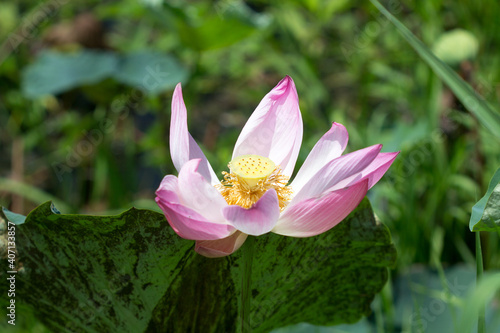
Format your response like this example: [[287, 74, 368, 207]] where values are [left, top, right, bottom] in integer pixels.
[[177, 158, 228, 224]]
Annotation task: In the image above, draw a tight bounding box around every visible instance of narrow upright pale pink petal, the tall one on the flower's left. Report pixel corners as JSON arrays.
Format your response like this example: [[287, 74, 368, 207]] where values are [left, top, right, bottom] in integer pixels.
[[170, 83, 219, 185]]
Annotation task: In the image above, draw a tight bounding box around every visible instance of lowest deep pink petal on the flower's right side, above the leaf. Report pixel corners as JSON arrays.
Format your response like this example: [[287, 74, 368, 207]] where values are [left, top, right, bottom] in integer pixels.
[[272, 180, 368, 237]]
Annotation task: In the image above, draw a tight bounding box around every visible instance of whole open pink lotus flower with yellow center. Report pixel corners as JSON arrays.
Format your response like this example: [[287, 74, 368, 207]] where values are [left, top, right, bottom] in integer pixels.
[[156, 76, 398, 257]]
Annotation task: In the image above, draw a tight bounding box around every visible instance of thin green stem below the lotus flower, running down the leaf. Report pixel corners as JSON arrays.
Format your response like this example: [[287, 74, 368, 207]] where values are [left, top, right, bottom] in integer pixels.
[[240, 236, 255, 333]]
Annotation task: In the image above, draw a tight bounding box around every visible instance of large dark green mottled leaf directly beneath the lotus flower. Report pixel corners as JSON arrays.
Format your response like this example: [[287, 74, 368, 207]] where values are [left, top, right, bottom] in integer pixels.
[[1, 200, 396, 333]]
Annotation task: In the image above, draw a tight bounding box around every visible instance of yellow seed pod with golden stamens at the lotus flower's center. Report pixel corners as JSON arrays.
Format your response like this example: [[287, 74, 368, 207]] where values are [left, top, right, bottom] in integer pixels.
[[215, 155, 292, 210]]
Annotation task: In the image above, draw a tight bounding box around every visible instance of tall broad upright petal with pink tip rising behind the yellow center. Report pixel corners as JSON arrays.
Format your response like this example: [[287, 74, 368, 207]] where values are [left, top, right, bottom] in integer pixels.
[[233, 76, 302, 176]]
